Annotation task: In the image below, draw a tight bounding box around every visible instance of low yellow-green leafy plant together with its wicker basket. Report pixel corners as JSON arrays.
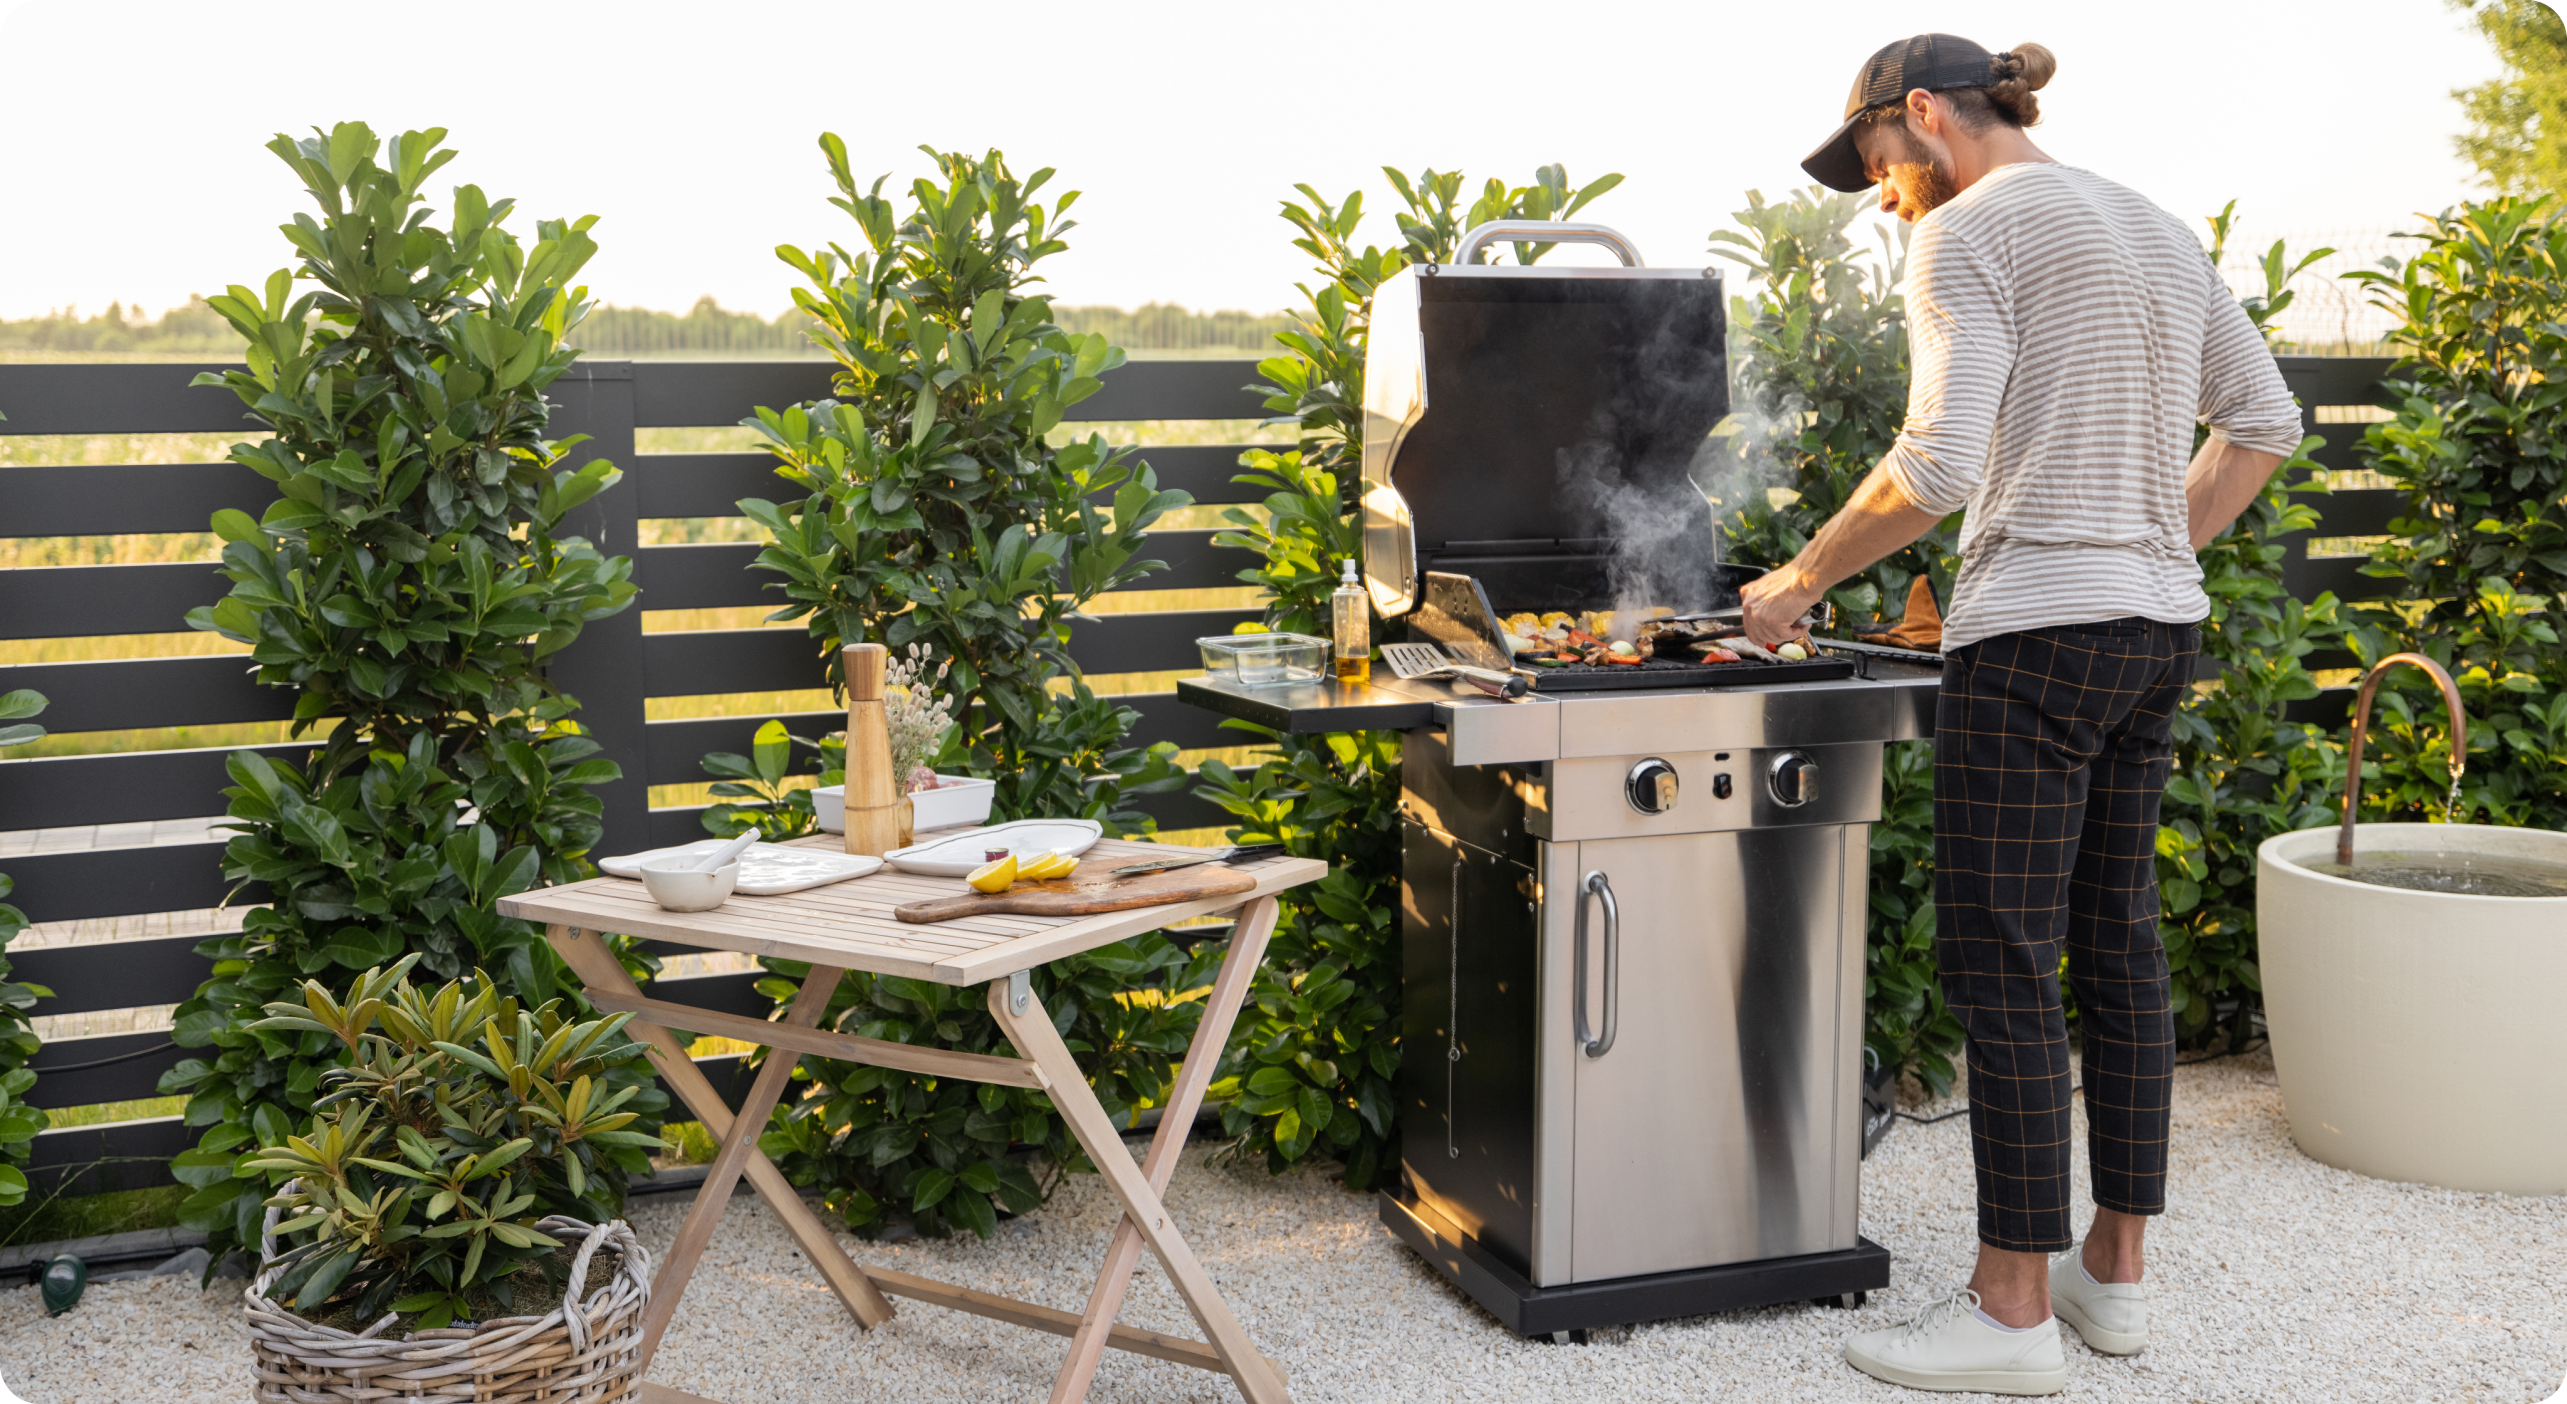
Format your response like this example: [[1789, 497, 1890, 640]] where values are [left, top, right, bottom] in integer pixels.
[[244, 955, 662, 1404]]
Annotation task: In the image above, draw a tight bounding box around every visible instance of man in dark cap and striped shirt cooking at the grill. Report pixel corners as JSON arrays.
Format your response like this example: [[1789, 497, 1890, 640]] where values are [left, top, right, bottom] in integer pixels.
[[1746, 33, 2300, 1394]]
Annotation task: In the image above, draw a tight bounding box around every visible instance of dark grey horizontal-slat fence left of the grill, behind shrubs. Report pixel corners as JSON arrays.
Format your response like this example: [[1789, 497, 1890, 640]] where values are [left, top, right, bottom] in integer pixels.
[[0, 362, 1263, 1191]]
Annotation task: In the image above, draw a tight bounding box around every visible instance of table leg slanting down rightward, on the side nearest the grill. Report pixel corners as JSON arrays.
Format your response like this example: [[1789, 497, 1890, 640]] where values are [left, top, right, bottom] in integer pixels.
[[988, 959, 1291, 1404]]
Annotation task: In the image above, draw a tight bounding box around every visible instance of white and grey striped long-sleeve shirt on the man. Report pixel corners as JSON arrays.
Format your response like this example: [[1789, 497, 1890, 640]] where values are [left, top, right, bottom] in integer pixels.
[[1882, 164, 2300, 649]]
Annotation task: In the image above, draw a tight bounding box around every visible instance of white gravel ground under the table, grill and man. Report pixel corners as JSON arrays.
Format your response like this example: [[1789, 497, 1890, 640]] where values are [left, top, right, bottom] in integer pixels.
[[0, 1057, 2567, 1404]]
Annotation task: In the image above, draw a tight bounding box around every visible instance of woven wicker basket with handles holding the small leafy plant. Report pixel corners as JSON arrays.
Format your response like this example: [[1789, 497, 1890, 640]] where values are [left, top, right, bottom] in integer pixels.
[[241, 1190, 649, 1404]]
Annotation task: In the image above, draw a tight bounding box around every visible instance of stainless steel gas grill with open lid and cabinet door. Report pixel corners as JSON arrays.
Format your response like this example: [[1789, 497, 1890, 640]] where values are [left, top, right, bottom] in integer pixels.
[[1178, 223, 1938, 1337]]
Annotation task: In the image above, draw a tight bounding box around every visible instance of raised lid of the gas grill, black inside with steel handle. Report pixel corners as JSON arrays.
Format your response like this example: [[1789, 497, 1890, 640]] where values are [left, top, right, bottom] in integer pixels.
[[1363, 221, 1735, 616]]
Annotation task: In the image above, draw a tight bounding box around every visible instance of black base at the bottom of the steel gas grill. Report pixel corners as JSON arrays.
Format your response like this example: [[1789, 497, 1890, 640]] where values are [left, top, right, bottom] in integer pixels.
[[1381, 1191, 1889, 1337]]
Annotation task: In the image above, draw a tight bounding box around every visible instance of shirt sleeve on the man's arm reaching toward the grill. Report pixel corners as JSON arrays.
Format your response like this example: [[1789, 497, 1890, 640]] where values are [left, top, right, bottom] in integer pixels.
[[1882, 223, 2015, 513]]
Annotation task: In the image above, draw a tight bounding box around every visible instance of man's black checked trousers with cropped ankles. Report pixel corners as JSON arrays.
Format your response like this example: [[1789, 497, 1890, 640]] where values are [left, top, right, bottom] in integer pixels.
[[1933, 619, 2200, 1253]]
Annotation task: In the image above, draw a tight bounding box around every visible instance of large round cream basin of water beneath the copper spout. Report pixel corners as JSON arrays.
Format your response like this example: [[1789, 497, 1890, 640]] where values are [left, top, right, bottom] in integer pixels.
[[2256, 824, 2567, 1194]]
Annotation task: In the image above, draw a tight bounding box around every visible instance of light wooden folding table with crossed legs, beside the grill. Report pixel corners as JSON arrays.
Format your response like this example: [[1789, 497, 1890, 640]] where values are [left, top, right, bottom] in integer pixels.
[[498, 837, 1327, 1404]]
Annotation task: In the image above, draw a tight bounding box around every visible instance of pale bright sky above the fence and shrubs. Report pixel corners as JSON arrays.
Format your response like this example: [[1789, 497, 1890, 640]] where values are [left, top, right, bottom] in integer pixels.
[[0, 0, 2498, 318]]
